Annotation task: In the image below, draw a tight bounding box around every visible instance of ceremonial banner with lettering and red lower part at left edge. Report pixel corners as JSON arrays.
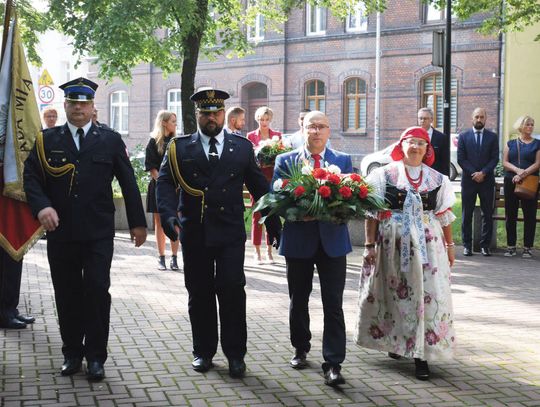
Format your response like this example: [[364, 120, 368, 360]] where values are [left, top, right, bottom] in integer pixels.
[[0, 16, 43, 260]]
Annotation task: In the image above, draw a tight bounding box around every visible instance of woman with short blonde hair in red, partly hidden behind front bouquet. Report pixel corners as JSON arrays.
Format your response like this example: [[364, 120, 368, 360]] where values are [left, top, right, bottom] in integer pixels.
[[247, 106, 281, 264]]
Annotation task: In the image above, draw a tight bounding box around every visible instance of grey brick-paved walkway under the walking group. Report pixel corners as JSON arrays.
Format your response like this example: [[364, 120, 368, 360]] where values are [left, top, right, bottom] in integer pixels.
[[0, 234, 540, 407]]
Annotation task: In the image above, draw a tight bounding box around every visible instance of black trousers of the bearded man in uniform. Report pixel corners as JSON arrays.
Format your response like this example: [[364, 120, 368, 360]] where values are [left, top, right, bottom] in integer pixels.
[[182, 239, 247, 359]]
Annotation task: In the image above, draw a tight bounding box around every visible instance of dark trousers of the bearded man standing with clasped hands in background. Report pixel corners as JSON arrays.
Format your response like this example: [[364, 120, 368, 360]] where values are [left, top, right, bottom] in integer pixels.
[[461, 180, 495, 249]]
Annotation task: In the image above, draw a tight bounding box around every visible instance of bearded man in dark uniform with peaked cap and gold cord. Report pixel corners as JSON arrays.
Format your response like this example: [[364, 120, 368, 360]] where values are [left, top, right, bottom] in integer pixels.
[[157, 89, 281, 377]]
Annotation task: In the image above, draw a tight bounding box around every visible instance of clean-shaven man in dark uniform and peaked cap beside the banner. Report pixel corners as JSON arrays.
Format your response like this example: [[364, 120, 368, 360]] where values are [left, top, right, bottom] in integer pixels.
[[24, 78, 146, 380]]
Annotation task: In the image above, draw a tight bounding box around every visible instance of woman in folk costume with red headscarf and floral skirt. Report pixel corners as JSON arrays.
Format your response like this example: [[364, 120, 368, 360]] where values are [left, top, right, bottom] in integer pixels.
[[355, 127, 456, 380]]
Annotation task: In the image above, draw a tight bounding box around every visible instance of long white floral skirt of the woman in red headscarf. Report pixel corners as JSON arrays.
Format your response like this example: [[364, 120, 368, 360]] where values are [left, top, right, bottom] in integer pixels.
[[354, 211, 456, 361]]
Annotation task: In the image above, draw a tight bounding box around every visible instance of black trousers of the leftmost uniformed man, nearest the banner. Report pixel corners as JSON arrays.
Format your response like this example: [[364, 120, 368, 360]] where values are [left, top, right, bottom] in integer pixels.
[[47, 238, 113, 363]]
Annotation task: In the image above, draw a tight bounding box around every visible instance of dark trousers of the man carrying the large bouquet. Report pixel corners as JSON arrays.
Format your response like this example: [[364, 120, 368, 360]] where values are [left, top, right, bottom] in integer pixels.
[[286, 246, 347, 370]]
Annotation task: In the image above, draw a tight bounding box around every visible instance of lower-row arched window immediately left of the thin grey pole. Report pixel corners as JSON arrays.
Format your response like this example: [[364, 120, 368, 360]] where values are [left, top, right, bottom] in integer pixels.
[[343, 78, 367, 133]]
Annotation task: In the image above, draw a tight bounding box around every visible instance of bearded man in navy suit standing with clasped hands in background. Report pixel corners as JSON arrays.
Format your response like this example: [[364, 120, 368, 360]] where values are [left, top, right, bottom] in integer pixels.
[[458, 107, 499, 256]]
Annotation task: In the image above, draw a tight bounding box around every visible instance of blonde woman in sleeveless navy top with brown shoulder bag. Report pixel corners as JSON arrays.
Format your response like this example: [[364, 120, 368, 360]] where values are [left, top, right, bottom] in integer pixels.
[[503, 115, 540, 259]]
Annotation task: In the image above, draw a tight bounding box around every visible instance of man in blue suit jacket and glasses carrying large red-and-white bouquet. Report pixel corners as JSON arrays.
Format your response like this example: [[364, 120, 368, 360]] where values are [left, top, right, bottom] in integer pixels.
[[274, 111, 353, 386]]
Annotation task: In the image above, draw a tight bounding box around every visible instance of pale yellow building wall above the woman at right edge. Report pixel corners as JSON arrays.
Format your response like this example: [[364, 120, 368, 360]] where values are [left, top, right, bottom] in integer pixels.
[[503, 23, 540, 140]]
